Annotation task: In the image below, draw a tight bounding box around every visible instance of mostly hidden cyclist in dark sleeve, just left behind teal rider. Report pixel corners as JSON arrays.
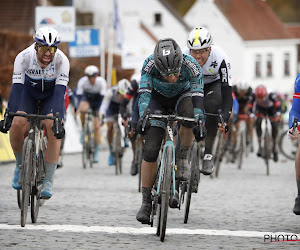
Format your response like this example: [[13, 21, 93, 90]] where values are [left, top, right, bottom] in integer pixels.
[[120, 73, 141, 175]]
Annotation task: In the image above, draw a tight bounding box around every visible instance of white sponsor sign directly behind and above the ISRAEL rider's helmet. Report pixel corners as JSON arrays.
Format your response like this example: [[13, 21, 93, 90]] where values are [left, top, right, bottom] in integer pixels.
[[35, 6, 76, 42]]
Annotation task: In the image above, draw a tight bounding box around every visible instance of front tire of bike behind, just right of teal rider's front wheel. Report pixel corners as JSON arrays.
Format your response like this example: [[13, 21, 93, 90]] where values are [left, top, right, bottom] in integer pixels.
[[183, 141, 200, 224]]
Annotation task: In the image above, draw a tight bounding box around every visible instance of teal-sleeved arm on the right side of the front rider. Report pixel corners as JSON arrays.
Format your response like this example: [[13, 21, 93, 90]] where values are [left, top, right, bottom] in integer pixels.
[[182, 55, 204, 119]]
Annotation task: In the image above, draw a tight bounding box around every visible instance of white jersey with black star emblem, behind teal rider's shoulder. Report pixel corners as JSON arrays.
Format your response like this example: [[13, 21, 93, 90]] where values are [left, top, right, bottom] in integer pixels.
[[183, 45, 232, 86]]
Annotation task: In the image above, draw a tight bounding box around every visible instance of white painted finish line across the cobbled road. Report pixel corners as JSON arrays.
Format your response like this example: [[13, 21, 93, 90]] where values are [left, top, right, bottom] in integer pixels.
[[0, 224, 300, 239]]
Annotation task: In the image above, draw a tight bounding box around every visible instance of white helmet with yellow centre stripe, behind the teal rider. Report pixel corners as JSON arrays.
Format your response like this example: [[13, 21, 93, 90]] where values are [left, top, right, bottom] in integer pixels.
[[187, 27, 213, 50]]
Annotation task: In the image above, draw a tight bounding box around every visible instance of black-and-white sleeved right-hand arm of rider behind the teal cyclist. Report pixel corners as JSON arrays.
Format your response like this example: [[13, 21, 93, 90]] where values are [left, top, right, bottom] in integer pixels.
[[219, 57, 233, 123]]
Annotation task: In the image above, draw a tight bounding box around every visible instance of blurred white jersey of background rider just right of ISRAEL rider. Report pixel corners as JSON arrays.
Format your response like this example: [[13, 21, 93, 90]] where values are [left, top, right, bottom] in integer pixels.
[[76, 76, 106, 96]]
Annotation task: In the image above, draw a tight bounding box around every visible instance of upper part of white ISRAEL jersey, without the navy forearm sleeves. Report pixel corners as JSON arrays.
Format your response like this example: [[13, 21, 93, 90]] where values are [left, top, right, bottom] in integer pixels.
[[12, 43, 70, 92]]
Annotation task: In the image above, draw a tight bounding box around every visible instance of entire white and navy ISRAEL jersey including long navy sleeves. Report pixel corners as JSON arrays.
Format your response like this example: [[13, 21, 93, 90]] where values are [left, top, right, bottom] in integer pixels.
[[8, 43, 70, 117]]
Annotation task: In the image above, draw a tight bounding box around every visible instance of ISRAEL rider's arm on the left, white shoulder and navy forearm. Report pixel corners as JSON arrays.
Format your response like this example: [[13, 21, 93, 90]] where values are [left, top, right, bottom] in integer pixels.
[[8, 49, 30, 112]]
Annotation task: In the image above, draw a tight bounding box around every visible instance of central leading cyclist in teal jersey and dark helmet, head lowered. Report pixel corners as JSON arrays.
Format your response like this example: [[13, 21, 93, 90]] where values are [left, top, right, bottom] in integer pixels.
[[136, 38, 203, 223]]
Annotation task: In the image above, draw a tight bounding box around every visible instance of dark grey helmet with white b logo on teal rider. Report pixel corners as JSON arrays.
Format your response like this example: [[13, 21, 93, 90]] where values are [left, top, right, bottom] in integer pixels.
[[154, 38, 182, 74]]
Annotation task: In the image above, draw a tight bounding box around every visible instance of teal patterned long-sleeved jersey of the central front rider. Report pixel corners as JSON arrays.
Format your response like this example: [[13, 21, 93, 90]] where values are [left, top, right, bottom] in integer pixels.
[[139, 54, 204, 118]]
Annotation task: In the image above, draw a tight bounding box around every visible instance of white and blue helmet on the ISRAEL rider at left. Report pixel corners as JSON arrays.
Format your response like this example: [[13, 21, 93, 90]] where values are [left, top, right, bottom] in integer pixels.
[[33, 26, 61, 47]]
